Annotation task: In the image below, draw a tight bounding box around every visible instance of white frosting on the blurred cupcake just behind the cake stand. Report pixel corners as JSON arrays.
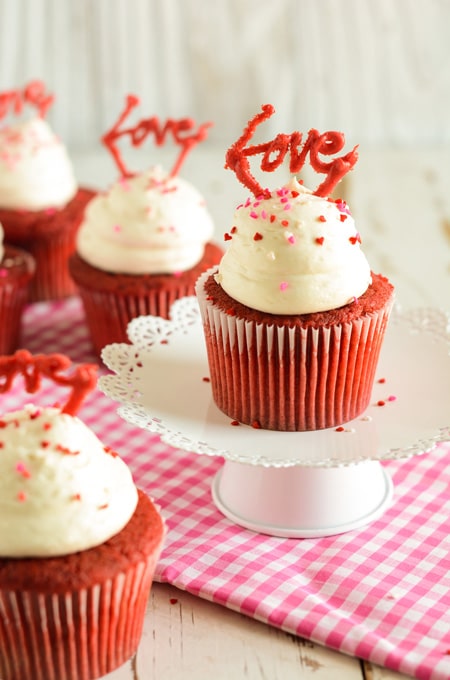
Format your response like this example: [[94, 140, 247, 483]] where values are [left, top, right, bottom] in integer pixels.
[[77, 167, 214, 274]]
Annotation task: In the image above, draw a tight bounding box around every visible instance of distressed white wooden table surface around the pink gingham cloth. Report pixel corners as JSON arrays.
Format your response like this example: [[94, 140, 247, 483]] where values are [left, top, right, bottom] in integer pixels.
[[74, 148, 450, 680]]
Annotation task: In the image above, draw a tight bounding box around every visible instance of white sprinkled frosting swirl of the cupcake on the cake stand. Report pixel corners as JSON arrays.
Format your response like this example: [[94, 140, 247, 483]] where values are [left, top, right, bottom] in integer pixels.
[[216, 178, 371, 314]]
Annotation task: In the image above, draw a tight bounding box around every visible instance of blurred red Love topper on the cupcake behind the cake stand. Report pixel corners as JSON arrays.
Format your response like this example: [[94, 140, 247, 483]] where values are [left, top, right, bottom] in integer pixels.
[[102, 94, 212, 177]]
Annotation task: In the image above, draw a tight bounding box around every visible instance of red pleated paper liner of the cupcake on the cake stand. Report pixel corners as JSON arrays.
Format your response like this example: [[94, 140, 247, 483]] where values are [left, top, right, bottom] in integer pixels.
[[197, 276, 392, 431]]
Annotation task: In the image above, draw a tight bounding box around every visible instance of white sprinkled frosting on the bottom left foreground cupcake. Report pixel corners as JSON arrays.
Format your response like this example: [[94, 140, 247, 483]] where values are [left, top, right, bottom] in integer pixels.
[[0, 405, 138, 557]]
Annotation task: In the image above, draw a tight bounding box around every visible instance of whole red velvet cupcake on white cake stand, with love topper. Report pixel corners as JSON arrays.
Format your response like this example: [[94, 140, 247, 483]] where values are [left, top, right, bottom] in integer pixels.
[[196, 106, 393, 431]]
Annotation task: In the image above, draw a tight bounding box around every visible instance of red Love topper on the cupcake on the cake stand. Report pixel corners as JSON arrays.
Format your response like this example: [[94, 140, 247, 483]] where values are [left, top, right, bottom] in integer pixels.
[[225, 104, 358, 197]]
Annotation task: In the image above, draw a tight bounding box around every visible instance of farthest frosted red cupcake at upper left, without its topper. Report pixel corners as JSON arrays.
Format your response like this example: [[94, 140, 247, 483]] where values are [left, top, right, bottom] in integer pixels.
[[0, 117, 94, 301]]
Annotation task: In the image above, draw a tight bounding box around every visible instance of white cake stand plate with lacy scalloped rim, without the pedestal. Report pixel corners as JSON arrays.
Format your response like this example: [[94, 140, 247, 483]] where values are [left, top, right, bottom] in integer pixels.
[[99, 297, 450, 467]]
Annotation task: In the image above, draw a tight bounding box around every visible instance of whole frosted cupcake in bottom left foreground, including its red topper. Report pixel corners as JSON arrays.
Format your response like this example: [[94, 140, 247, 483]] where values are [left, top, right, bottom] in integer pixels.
[[0, 350, 165, 680]]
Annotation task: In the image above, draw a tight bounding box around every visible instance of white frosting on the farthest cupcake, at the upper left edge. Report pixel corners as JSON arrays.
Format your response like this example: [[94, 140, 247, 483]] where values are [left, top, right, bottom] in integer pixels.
[[0, 118, 78, 210]]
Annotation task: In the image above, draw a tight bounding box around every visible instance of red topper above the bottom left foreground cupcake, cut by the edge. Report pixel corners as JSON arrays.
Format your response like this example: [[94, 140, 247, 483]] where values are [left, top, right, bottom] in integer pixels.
[[0, 349, 97, 416]]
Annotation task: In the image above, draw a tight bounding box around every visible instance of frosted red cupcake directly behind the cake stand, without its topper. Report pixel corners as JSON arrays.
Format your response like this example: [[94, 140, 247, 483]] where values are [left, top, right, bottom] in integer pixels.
[[70, 167, 223, 354]]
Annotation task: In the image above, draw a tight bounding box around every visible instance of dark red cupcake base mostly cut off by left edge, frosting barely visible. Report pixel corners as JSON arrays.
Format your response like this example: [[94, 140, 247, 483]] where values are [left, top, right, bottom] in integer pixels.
[[0, 224, 35, 354]]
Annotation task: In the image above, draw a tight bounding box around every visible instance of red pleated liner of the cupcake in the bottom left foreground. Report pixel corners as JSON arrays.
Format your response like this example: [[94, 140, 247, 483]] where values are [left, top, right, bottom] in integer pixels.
[[0, 553, 159, 680]]
